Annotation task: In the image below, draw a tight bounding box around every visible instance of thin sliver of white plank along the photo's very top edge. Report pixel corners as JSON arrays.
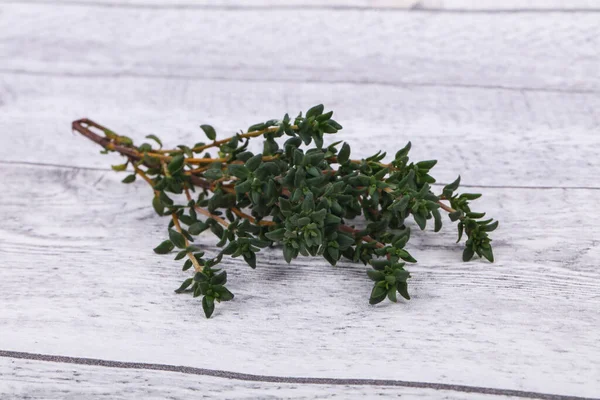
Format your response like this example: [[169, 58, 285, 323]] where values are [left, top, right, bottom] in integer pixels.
[[0, 0, 598, 12]]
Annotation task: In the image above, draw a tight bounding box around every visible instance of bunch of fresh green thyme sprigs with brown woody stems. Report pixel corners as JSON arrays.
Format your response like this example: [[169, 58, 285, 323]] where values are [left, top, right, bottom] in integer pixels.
[[73, 105, 498, 317]]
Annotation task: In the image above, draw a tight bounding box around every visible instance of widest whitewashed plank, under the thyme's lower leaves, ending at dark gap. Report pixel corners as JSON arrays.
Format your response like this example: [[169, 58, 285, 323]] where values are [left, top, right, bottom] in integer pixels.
[[0, 165, 600, 396]]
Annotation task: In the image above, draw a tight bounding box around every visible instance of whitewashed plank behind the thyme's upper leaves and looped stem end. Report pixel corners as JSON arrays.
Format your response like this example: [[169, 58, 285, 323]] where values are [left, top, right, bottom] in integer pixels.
[[0, 75, 600, 187]]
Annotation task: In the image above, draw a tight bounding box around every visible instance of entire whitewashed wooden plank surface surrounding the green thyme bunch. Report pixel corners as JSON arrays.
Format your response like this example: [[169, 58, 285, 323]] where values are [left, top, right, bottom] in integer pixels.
[[0, 1, 600, 399]]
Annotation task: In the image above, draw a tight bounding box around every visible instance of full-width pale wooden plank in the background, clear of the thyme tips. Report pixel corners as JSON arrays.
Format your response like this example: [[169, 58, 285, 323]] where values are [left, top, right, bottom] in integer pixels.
[[0, 4, 600, 92]]
